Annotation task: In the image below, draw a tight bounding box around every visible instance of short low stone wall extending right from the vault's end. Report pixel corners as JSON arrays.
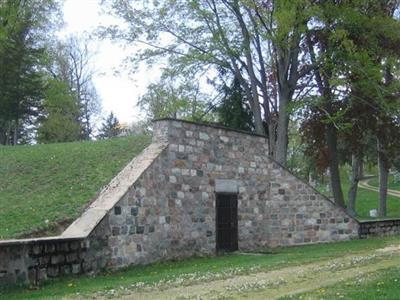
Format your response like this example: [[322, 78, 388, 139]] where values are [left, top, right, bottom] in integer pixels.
[[359, 219, 400, 238]]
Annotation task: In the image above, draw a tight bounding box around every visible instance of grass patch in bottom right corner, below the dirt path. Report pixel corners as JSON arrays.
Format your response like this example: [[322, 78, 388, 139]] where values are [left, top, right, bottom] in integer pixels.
[[283, 267, 400, 300]]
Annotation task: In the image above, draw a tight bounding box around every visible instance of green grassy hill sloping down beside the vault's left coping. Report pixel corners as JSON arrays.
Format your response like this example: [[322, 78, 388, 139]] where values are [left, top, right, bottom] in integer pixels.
[[0, 136, 150, 239]]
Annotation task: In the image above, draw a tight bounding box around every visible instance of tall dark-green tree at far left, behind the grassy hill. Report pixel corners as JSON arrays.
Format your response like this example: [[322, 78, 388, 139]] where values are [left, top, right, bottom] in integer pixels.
[[0, 0, 59, 145]]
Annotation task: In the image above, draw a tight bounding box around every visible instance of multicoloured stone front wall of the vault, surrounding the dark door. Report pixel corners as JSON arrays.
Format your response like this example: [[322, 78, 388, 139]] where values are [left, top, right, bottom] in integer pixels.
[[101, 120, 358, 268]]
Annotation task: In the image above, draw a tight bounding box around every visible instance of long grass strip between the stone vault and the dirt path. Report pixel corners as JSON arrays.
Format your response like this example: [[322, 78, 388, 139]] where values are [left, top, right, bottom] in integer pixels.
[[0, 237, 399, 299]]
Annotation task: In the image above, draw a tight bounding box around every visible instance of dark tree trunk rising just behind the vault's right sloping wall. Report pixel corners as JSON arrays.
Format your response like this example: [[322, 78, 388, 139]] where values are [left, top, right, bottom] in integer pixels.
[[326, 124, 345, 207]]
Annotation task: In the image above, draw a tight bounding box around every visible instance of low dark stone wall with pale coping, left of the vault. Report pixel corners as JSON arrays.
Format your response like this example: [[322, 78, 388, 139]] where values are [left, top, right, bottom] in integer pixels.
[[0, 219, 109, 287]]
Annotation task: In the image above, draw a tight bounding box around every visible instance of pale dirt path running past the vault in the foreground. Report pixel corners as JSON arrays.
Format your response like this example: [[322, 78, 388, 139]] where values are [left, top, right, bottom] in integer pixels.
[[85, 245, 400, 299]]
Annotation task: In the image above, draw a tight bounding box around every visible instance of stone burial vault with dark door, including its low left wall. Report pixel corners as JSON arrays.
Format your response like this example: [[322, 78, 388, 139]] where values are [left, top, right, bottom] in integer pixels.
[[0, 119, 359, 284]]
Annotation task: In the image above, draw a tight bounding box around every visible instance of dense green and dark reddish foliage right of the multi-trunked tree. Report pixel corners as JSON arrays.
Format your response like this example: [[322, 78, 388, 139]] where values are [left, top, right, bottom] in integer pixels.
[[302, 1, 400, 209]]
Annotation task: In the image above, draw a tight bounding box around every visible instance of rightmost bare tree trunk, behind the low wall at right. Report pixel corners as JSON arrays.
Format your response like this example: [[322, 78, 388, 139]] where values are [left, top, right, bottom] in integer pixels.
[[377, 137, 389, 217]]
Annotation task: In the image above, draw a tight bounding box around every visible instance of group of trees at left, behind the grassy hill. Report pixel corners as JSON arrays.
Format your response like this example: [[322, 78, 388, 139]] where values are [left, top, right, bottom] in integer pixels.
[[0, 0, 118, 145]]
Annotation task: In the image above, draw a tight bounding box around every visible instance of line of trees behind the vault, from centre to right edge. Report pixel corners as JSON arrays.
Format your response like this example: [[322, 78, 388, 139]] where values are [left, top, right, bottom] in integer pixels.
[[102, 0, 400, 216]]
